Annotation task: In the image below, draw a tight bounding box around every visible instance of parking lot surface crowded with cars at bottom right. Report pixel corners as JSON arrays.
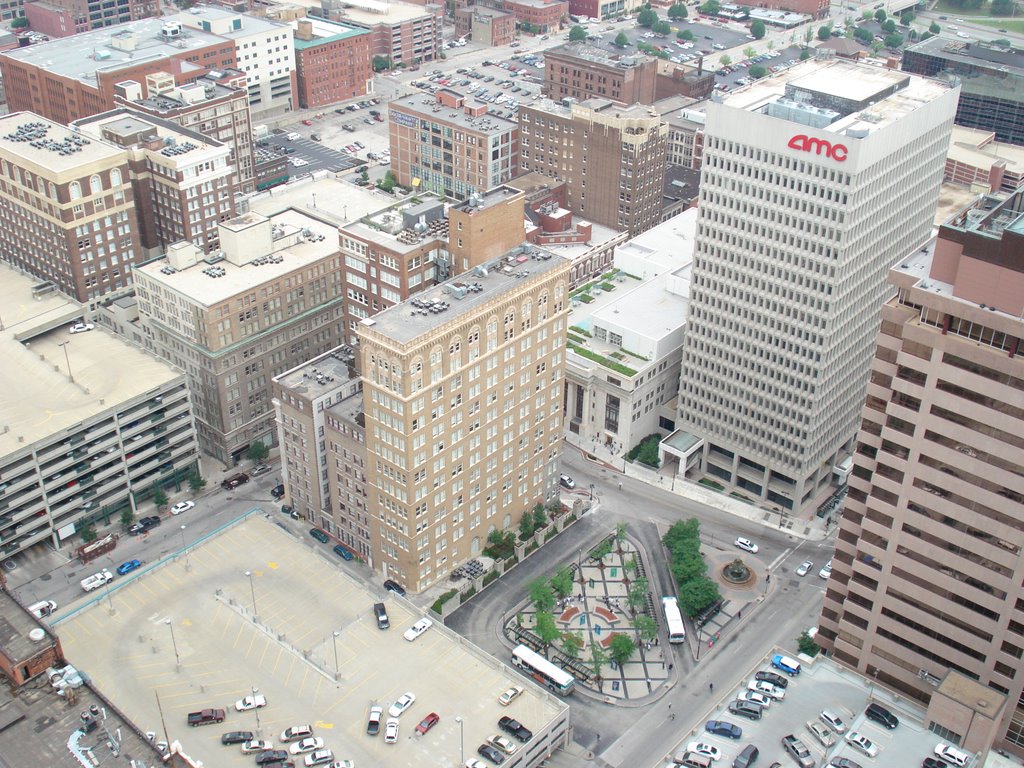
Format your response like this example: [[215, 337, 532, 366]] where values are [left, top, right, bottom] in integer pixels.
[[669, 655, 970, 768]]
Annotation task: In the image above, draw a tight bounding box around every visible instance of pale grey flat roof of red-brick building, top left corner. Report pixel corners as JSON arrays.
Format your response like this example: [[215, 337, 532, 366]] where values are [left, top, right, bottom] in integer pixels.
[[0, 16, 224, 83]]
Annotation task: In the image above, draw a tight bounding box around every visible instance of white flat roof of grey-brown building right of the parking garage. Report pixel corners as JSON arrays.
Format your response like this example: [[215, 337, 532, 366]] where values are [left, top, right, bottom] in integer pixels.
[[135, 209, 338, 307]]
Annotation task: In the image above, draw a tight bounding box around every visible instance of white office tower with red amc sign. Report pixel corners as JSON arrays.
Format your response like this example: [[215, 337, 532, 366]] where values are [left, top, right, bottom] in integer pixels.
[[669, 59, 958, 516]]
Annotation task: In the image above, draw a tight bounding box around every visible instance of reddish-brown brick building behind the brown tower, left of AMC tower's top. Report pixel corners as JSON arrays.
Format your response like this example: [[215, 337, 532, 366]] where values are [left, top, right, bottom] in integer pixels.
[[544, 42, 657, 104]]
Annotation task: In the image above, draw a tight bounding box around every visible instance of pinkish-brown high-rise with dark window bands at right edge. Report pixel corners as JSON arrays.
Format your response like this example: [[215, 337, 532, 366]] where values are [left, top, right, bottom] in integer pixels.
[[817, 187, 1024, 756]]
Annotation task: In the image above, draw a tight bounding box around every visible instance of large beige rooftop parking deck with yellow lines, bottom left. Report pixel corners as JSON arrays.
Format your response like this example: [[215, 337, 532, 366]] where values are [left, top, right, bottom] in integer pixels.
[[56, 511, 568, 768]]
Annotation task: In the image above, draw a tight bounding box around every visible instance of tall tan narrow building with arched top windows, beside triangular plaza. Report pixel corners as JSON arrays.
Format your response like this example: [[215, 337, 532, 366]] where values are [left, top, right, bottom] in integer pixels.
[[358, 246, 568, 593]]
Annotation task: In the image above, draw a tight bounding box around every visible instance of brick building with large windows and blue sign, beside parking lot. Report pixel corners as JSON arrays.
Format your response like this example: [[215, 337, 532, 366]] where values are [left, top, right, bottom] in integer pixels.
[[388, 89, 519, 200]]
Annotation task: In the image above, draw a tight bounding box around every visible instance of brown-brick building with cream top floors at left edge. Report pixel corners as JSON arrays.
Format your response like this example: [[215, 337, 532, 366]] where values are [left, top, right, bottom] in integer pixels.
[[0, 113, 140, 303]]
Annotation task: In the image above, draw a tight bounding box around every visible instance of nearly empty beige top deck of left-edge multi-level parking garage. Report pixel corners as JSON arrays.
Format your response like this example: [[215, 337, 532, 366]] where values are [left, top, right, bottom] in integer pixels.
[[0, 264, 182, 456]]
